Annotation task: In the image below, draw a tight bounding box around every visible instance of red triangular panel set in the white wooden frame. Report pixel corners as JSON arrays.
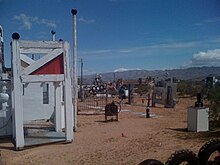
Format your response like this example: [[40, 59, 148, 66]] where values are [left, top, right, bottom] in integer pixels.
[[31, 54, 64, 75]]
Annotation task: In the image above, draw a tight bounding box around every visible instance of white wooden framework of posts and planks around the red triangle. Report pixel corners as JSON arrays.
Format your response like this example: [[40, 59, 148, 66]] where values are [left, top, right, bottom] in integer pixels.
[[12, 39, 73, 150]]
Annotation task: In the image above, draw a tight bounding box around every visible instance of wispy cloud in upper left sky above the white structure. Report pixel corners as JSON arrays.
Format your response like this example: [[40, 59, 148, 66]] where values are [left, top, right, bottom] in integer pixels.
[[13, 13, 56, 30]]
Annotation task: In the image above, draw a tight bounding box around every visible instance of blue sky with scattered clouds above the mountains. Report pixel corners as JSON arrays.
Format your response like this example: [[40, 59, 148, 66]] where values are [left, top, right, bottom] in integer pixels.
[[0, 0, 220, 74]]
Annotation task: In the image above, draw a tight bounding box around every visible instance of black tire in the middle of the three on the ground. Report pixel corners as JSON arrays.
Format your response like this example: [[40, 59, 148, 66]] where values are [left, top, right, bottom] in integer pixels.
[[165, 149, 199, 165]]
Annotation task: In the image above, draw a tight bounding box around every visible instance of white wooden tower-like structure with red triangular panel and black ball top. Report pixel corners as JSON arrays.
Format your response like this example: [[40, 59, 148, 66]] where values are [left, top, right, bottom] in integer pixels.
[[11, 33, 76, 150]]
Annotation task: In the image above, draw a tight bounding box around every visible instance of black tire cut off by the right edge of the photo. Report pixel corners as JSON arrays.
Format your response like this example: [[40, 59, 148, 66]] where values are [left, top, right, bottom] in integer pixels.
[[198, 139, 220, 165]]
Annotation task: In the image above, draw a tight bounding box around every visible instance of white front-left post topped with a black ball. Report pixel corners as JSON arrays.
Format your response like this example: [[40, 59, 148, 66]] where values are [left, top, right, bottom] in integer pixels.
[[11, 33, 24, 150]]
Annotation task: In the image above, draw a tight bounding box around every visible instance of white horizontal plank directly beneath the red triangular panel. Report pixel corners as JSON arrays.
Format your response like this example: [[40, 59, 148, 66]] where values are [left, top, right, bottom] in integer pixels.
[[21, 74, 64, 83]]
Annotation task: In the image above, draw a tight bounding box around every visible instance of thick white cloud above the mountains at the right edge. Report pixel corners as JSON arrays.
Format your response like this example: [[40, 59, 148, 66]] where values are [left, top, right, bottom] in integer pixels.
[[190, 49, 220, 66]]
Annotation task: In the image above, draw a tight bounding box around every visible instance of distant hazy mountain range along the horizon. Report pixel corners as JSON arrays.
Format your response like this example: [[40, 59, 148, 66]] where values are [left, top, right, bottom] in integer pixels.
[[83, 67, 220, 83]]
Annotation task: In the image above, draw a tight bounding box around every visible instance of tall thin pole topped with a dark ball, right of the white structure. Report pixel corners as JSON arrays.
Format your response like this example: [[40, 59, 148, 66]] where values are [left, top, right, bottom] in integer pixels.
[[71, 9, 78, 131]]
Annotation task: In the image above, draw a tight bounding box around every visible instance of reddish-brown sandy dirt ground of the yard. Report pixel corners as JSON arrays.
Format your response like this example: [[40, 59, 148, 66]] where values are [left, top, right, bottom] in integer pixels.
[[0, 98, 219, 165]]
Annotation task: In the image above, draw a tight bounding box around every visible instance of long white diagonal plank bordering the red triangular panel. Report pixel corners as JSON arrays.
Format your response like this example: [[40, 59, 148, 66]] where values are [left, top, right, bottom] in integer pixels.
[[22, 49, 63, 74]]
